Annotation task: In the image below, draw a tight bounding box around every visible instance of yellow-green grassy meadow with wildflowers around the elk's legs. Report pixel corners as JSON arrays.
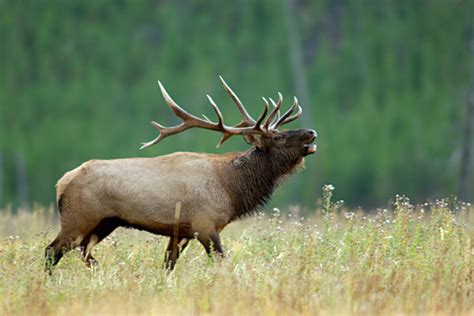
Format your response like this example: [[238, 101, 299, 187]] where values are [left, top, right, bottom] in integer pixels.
[[0, 197, 474, 315]]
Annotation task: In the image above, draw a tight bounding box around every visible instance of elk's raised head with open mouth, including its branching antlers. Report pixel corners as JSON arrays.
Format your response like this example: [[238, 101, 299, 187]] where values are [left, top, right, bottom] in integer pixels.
[[140, 77, 317, 160]]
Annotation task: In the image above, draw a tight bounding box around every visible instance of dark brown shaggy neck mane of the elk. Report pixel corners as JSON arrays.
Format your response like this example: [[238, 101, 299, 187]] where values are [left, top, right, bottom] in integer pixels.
[[224, 148, 303, 221]]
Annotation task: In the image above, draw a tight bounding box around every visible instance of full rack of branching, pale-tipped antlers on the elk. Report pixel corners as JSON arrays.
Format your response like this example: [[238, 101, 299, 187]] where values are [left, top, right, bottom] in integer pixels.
[[140, 76, 302, 149]]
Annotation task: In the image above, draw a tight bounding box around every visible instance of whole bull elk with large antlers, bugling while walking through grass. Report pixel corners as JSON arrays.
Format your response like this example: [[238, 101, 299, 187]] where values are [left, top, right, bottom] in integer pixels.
[[45, 77, 316, 272]]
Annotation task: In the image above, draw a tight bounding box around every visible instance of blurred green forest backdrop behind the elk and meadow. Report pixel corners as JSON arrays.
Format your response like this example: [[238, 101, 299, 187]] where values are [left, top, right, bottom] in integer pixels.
[[0, 0, 474, 211]]
